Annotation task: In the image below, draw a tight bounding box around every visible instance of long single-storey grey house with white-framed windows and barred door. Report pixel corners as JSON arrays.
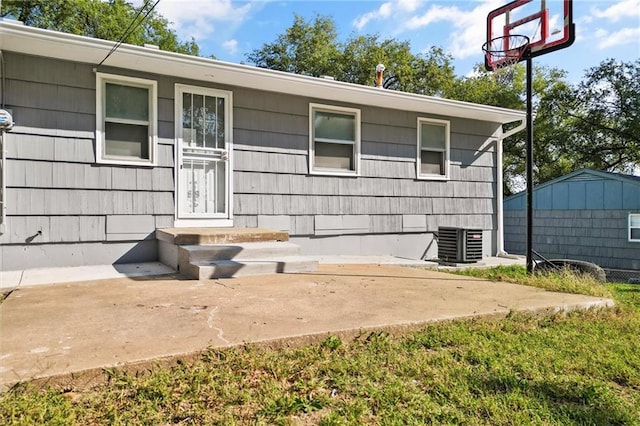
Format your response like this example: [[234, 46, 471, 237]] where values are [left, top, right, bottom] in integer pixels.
[[0, 20, 524, 270]]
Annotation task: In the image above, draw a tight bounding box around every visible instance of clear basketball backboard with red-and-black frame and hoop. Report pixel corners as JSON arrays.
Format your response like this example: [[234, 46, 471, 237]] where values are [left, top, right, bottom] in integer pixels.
[[485, 0, 575, 70]]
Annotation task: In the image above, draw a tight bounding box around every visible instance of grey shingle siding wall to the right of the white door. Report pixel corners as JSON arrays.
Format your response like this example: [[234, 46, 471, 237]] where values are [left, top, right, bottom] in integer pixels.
[[233, 89, 498, 255]]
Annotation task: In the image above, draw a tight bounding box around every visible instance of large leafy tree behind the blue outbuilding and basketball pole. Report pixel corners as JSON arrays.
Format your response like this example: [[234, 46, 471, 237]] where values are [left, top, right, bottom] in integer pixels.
[[464, 59, 640, 195]]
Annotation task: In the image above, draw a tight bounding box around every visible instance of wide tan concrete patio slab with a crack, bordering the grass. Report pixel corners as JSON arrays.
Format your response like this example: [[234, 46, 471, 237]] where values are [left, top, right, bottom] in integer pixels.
[[0, 264, 613, 389]]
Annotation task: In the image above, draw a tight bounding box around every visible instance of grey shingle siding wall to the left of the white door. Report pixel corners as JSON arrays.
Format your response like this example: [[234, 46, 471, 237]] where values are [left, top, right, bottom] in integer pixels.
[[0, 52, 174, 270]]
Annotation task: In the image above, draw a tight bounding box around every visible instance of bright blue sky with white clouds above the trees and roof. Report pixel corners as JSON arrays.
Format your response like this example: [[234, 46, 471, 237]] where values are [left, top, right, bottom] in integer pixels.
[[148, 0, 640, 82]]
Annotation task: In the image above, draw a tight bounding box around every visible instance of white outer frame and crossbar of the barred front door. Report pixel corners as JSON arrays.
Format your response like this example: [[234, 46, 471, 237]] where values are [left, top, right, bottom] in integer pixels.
[[173, 83, 233, 223]]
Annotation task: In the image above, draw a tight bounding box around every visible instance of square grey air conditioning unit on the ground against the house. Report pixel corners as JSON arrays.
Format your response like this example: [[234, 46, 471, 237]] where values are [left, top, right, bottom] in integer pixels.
[[438, 227, 482, 263]]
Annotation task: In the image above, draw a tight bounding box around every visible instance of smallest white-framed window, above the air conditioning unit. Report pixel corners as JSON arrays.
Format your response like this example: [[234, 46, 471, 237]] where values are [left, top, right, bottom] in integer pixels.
[[417, 118, 449, 179]]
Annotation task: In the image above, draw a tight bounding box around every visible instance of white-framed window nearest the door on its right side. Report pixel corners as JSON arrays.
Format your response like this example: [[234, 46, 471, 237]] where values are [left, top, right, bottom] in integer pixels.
[[309, 104, 360, 175]]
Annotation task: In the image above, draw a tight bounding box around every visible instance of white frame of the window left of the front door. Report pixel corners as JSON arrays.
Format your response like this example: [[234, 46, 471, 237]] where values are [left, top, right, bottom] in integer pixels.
[[96, 73, 158, 166]]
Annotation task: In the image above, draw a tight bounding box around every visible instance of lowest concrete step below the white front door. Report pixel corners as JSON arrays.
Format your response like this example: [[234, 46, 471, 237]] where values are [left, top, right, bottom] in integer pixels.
[[190, 256, 318, 280]]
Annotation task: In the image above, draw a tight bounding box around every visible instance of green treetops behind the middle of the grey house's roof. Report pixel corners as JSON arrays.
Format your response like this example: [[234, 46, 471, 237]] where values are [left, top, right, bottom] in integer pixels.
[[247, 15, 454, 95]]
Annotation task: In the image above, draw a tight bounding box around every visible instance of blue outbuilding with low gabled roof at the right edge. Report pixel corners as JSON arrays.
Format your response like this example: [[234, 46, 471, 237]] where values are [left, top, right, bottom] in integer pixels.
[[504, 169, 640, 271]]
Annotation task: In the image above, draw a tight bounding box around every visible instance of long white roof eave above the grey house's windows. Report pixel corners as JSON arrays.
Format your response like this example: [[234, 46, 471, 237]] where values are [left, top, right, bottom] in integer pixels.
[[0, 20, 525, 124]]
